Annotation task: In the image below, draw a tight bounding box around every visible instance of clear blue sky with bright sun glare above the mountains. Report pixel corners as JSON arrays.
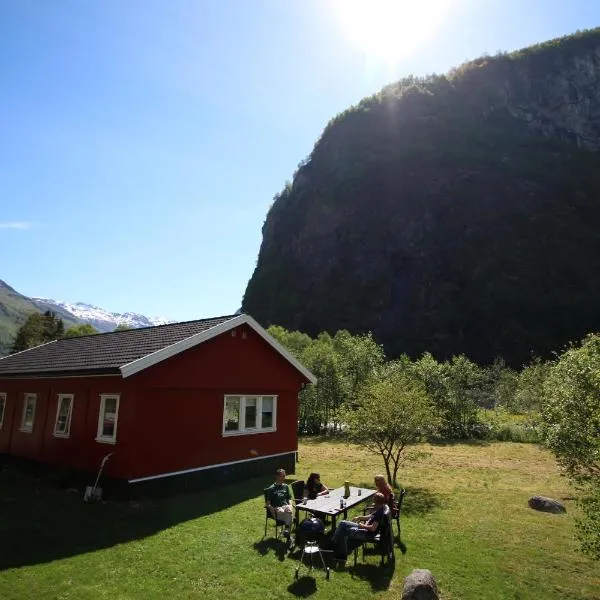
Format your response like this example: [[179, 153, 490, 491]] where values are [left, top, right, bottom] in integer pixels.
[[0, 0, 600, 319]]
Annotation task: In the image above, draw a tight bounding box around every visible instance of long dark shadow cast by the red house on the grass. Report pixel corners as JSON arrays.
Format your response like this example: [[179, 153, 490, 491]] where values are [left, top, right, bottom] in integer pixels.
[[0, 469, 265, 571]]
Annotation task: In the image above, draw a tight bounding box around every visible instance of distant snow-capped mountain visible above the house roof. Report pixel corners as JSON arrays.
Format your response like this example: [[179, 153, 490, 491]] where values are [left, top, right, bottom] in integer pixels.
[[32, 298, 175, 332]]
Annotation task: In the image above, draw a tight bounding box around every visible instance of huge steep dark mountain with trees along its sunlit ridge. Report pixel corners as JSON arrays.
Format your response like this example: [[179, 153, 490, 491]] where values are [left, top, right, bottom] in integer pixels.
[[242, 29, 600, 364]]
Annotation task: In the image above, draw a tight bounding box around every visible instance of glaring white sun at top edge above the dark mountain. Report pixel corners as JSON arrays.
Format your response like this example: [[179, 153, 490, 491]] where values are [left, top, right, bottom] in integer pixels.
[[332, 0, 455, 62]]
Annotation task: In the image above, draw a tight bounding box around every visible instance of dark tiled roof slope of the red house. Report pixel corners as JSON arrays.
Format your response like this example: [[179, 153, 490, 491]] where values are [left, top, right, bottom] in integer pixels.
[[0, 315, 236, 377]]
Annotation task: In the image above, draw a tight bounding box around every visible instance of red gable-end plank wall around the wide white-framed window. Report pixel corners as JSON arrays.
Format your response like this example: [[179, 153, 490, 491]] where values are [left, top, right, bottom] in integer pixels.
[[129, 325, 306, 478]]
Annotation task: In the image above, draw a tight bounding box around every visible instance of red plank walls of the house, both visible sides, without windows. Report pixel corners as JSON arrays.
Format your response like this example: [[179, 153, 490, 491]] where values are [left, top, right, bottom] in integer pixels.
[[0, 325, 306, 479]]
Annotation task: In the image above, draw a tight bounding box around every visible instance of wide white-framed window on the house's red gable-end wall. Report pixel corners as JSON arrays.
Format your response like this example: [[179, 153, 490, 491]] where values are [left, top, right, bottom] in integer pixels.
[[223, 396, 277, 435]]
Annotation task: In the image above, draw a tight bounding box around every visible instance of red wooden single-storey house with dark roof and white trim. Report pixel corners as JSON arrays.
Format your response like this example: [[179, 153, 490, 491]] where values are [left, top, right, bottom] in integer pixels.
[[0, 315, 315, 487]]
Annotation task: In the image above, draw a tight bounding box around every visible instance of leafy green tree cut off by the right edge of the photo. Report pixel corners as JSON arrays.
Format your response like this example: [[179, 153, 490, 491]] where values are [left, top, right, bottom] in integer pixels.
[[541, 334, 600, 559]]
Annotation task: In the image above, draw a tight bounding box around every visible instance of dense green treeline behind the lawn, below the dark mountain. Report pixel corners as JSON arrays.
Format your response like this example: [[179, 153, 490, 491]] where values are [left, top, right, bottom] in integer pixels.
[[269, 326, 555, 441]]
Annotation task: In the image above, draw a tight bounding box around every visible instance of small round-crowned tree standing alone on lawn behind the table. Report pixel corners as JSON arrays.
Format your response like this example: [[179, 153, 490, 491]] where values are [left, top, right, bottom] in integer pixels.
[[344, 371, 437, 485]]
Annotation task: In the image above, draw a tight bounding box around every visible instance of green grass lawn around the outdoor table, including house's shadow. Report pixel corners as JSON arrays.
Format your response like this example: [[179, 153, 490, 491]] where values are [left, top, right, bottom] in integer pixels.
[[0, 439, 600, 600]]
